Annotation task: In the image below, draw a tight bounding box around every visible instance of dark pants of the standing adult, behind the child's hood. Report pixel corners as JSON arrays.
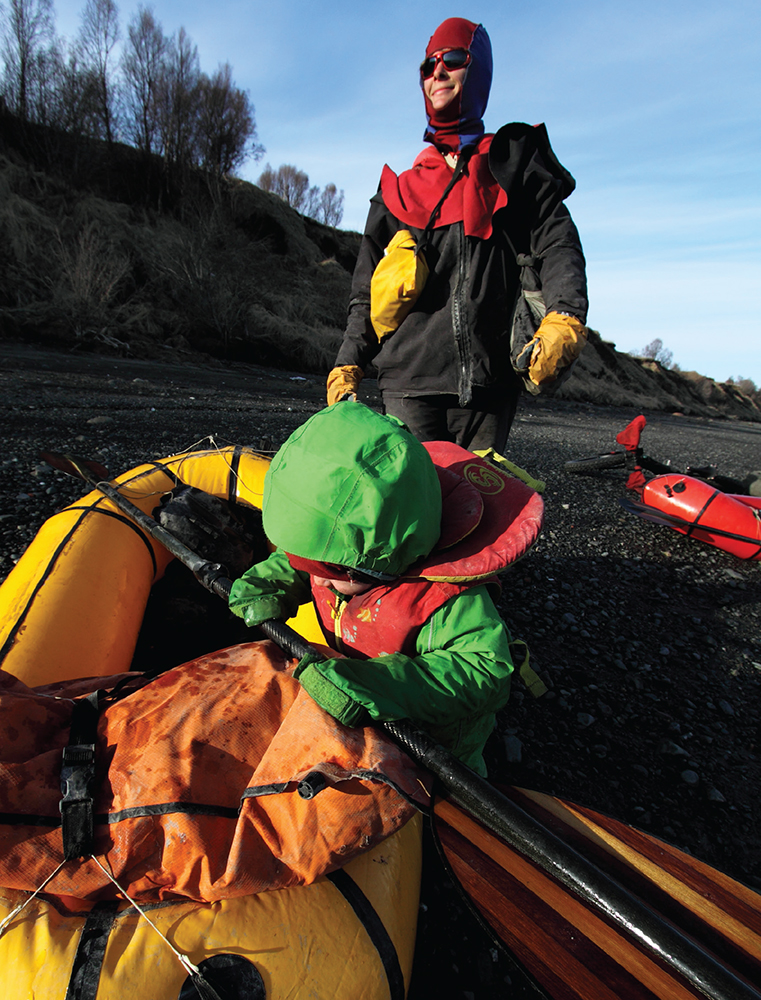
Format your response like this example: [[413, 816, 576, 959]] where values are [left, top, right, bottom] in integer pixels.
[[383, 390, 519, 454]]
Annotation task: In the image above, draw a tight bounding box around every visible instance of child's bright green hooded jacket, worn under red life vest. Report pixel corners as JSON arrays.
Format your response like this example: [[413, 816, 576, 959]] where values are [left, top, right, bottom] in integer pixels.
[[230, 401, 513, 774]]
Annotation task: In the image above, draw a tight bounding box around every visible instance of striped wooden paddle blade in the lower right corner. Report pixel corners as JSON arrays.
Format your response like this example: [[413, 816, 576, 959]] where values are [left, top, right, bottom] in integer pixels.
[[435, 788, 761, 1000]]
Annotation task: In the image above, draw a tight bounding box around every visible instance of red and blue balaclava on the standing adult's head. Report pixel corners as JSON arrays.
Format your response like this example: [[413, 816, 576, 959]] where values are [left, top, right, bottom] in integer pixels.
[[420, 17, 492, 152]]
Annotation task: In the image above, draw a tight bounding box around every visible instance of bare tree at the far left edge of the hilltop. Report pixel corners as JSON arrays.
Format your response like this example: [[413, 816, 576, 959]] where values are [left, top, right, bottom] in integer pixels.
[[2, 0, 54, 120]]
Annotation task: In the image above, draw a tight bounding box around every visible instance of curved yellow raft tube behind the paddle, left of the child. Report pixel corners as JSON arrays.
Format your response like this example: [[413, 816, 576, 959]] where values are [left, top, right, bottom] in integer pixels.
[[0, 446, 276, 687]]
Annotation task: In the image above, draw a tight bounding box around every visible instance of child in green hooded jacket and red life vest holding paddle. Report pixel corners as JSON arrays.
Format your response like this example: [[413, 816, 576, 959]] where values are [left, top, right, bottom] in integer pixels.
[[230, 401, 541, 774]]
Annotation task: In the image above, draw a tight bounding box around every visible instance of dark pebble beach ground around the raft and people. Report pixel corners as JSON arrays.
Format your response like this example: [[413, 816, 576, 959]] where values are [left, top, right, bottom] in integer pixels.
[[0, 345, 761, 1000]]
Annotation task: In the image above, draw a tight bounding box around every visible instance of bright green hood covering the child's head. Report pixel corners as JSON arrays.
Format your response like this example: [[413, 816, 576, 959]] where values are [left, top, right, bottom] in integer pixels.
[[262, 401, 441, 575]]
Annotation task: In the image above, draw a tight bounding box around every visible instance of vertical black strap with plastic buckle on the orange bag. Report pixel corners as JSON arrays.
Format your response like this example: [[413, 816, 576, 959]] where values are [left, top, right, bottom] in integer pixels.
[[59, 691, 102, 861]]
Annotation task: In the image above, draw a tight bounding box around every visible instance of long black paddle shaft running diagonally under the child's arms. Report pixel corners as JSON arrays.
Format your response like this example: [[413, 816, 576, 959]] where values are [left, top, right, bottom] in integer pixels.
[[52, 462, 761, 1000]]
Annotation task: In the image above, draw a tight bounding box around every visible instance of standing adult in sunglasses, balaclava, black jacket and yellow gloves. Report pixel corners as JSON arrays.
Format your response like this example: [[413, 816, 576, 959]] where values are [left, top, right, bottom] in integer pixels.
[[328, 17, 587, 452]]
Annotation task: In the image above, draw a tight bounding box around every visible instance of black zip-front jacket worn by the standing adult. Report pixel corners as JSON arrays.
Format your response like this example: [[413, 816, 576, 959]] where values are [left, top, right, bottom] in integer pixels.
[[335, 124, 587, 406]]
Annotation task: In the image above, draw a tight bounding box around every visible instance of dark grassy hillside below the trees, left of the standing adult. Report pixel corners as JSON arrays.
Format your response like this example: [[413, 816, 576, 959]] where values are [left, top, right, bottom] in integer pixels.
[[0, 107, 359, 371]]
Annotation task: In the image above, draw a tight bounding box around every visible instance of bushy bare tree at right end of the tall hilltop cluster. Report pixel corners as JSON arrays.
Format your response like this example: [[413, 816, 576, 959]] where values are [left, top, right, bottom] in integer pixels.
[[198, 63, 264, 177]]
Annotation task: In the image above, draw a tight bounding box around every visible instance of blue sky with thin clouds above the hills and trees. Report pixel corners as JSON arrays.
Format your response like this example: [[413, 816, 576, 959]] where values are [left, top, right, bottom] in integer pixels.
[[54, 0, 761, 385]]
